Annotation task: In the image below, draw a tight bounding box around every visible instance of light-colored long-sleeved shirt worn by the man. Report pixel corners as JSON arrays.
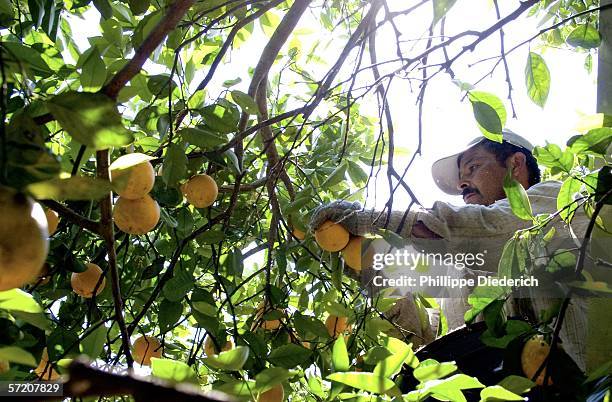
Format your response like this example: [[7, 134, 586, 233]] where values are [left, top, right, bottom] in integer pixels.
[[375, 181, 589, 370]]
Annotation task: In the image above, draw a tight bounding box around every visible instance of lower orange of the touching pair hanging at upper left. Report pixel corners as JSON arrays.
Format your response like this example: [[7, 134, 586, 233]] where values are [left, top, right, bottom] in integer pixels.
[[113, 194, 160, 235]]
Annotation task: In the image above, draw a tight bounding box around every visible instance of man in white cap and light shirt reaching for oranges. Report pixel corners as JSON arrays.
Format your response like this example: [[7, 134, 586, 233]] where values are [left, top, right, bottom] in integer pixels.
[[311, 130, 588, 370]]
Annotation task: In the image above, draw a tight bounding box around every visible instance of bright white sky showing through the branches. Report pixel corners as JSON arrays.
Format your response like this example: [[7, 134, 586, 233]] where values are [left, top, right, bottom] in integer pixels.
[[64, 0, 597, 212]]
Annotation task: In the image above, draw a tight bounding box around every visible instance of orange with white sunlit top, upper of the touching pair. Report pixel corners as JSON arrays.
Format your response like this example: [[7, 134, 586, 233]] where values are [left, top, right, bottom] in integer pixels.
[[110, 153, 155, 200]]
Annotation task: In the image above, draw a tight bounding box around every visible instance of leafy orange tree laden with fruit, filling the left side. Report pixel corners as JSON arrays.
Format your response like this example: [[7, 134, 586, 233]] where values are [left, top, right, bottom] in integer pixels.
[[0, 0, 610, 401]]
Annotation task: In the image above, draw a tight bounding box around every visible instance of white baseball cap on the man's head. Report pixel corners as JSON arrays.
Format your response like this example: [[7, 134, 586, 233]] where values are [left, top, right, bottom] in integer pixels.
[[431, 129, 533, 195]]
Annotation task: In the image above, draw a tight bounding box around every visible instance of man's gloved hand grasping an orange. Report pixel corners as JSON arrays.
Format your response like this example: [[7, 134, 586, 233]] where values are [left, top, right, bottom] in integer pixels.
[[310, 201, 378, 236]]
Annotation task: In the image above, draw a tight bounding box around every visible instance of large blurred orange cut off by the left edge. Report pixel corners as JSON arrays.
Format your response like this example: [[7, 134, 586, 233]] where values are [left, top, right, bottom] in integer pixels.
[[0, 186, 49, 291]]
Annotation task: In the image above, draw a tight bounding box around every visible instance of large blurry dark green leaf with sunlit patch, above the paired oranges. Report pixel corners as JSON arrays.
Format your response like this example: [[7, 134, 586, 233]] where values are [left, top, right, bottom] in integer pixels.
[[46, 91, 134, 149]]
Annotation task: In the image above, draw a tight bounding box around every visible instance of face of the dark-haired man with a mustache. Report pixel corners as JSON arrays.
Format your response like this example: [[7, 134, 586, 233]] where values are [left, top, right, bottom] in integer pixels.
[[458, 146, 506, 205]]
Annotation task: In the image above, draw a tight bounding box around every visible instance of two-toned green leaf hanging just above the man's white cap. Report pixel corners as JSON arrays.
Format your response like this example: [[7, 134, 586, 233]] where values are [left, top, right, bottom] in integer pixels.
[[468, 91, 506, 142]]
